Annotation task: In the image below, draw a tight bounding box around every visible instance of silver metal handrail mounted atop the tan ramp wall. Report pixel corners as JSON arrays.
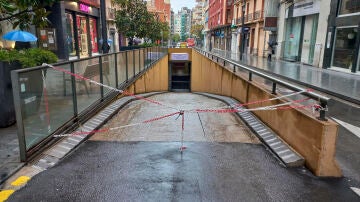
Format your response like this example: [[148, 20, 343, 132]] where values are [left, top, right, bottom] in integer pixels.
[[195, 47, 330, 121]]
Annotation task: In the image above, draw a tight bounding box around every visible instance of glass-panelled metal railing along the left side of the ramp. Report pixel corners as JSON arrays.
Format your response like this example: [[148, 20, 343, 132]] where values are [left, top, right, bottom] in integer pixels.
[[11, 47, 167, 161]]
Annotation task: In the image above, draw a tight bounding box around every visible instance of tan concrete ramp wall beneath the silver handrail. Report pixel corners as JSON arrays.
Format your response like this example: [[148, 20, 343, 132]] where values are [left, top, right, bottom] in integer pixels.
[[191, 51, 341, 177]]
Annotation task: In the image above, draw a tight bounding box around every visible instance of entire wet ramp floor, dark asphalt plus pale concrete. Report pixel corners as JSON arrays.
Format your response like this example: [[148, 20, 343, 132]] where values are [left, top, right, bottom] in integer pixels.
[[3, 93, 360, 201]]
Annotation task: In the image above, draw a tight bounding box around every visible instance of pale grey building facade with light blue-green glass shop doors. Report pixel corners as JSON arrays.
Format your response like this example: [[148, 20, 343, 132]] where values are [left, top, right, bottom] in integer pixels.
[[276, 0, 330, 67]]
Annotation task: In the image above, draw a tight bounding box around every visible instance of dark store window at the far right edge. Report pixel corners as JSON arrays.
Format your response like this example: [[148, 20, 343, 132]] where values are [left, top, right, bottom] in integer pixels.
[[332, 27, 358, 70]]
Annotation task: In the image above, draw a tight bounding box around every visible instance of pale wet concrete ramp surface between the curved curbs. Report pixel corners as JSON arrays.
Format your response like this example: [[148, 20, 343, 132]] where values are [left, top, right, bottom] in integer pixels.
[[90, 93, 260, 144]]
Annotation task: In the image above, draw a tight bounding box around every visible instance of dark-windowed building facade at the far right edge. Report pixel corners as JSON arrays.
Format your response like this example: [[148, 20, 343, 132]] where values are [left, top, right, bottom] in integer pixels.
[[323, 0, 360, 73]]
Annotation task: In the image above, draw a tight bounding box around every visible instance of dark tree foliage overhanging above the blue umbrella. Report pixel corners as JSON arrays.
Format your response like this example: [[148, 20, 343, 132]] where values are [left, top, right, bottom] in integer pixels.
[[0, 0, 60, 31]]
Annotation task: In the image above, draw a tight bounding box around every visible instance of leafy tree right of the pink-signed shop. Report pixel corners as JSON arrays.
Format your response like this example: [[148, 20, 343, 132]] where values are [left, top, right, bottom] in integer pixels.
[[113, 0, 153, 46]]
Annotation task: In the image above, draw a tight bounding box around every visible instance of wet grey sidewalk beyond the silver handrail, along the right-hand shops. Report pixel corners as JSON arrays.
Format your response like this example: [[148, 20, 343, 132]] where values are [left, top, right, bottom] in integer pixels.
[[212, 50, 360, 104]]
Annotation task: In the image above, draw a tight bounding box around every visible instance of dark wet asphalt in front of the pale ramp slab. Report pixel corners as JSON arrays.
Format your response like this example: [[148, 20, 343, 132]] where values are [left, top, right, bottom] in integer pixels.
[[9, 141, 359, 201]]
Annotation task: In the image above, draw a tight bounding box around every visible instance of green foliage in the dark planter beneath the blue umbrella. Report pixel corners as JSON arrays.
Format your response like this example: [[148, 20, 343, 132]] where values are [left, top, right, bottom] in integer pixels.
[[0, 48, 58, 67]]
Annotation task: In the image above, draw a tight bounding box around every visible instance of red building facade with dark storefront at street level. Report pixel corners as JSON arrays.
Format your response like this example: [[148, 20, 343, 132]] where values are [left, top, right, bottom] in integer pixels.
[[208, 0, 234, 51]]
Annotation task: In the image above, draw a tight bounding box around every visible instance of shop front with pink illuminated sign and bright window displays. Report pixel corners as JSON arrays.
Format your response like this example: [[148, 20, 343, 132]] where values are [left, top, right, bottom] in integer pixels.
[[65, 0, 101, 59]]
